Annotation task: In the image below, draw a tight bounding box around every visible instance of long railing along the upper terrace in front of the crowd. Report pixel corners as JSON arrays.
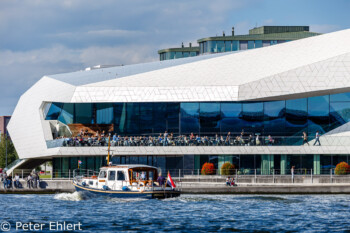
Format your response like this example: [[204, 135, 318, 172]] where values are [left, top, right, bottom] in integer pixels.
[[47, 134, 350, 148]]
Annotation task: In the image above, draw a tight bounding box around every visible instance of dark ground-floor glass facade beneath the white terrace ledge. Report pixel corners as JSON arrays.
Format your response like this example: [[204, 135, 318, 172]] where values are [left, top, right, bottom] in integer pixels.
[[53, 154, 349, 178]]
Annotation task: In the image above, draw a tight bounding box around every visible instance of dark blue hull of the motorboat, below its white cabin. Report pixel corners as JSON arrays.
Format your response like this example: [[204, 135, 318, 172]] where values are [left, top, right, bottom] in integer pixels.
[[73, 183, 180, 199]]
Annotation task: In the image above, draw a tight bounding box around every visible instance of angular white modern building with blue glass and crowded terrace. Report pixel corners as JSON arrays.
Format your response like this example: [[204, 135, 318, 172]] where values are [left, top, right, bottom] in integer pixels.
[[8, 27, 350, 177]]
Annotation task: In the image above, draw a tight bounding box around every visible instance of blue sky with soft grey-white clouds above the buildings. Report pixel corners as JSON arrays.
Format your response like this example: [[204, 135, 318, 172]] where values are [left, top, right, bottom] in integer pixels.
[[0, 0, 350, 116]]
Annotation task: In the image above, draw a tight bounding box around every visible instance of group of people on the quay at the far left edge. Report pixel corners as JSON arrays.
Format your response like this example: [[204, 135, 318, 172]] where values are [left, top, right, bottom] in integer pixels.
[[0, 169, 40, 189]]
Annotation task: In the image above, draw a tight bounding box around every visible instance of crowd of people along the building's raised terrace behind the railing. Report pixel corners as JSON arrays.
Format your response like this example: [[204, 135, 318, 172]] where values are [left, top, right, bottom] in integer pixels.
[[56, 130, 320, 146]]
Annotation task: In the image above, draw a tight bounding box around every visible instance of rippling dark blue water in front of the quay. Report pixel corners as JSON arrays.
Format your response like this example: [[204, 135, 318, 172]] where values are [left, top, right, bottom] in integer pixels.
[[0, 193, 350, 232]]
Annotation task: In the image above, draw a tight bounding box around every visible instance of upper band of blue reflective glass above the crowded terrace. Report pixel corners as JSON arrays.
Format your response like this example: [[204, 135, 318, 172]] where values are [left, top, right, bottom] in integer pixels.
[[46, 93, 350, 137]]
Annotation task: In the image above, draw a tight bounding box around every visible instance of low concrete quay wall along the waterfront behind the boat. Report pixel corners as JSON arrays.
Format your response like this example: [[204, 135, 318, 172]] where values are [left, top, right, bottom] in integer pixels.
[[0, 177, 350, 194]]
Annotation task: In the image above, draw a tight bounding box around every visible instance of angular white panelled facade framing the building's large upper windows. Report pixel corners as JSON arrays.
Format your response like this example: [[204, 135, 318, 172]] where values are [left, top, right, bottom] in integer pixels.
[[8, 30, 350, 158]]
